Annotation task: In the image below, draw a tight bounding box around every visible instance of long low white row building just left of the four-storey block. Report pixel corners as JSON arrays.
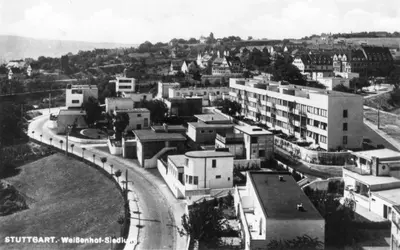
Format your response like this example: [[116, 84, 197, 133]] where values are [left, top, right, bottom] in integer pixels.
[[168, 86, 229, 106]]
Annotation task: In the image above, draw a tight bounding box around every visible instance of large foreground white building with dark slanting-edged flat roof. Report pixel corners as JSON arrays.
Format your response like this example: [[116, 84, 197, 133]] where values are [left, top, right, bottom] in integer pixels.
[[235, 171, 325, 250]]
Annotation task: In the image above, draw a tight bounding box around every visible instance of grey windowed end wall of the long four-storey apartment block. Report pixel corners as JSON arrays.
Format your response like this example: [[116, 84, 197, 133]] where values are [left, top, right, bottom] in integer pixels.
[[328, 96, 364, 149]]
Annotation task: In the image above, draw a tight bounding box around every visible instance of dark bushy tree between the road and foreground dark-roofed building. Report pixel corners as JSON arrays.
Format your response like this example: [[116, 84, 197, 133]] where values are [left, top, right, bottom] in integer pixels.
[[182, 199, 226, 246]]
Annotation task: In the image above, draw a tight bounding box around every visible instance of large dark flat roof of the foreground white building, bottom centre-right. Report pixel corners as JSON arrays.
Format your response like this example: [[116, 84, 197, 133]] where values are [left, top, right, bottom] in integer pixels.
[[248, 171, 323, 220]]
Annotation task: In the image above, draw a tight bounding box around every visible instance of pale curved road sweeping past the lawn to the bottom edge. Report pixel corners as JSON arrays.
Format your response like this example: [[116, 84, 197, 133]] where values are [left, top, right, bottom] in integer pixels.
[[28, 109, 182, 249]]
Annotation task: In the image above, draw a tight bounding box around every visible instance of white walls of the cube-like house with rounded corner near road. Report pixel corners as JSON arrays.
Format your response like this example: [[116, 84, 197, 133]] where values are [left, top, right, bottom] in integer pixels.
[[184, 157, 233, 190]]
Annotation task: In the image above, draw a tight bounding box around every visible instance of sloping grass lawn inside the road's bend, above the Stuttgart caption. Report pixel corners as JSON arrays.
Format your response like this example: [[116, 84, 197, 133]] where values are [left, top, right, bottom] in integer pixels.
[[0, 154, 124, 249]]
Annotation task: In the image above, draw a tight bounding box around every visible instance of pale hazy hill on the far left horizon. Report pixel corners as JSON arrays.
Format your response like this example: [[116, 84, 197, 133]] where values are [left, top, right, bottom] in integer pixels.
[[0, 35, 137, 61]]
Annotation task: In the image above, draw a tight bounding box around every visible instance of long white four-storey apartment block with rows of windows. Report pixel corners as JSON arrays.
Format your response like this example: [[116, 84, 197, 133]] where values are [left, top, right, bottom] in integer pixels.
[[229, 78, 363, 150]]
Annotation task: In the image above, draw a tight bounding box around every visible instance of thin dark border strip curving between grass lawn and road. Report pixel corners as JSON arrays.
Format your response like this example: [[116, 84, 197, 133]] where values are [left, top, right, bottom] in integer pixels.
[[29, 138, 131, 250]]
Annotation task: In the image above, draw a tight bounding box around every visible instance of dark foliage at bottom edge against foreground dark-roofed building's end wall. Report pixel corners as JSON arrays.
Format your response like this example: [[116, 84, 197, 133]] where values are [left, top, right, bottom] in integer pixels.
[[267, 234, 324, 250]]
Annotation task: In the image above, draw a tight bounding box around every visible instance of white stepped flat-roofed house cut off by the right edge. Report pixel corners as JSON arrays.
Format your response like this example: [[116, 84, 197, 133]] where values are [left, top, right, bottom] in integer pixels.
[[343, 149, 400, 220]]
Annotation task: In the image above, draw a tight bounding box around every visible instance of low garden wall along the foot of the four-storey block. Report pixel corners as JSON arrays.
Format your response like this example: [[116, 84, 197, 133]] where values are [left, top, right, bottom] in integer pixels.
[[274, 136, 350, 165]]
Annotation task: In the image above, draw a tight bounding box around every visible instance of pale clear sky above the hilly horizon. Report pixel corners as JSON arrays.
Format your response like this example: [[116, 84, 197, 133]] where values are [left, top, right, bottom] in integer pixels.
[[0, 0, 400, 44]]
